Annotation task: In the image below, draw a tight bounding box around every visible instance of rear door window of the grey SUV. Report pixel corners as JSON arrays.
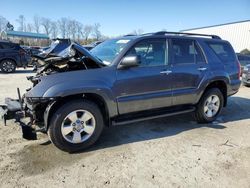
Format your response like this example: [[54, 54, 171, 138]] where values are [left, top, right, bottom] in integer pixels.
[[172, 39, 205, 64]]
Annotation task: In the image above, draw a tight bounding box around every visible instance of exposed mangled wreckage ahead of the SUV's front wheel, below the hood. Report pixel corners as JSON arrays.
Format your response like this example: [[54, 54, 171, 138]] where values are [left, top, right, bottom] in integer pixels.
[[0, 89, 56, 140]]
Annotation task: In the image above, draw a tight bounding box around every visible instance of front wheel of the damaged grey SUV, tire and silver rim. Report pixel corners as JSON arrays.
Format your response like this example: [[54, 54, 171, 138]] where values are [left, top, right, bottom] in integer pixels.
[[48, 100, 104, 152]]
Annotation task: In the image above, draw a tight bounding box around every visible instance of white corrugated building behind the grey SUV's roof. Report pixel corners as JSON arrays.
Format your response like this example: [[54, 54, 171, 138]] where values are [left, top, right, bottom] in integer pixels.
[[181, 20, 250, 52]]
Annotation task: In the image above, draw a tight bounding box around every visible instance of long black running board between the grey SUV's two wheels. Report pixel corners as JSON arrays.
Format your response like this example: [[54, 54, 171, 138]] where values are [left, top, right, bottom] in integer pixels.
[[112, 107, 196, 126]]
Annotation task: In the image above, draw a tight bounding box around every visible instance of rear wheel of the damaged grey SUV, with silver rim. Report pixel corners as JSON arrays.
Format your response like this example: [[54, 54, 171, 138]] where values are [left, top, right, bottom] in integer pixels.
[[195, 88, 224, 123]]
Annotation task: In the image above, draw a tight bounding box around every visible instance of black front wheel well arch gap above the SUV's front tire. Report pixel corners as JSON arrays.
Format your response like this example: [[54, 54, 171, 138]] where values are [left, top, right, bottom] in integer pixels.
[[46, 93, 110, 129]]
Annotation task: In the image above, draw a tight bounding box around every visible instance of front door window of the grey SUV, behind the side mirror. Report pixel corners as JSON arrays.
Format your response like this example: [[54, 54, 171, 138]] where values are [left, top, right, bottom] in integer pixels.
[[126, 39, 167, 66]]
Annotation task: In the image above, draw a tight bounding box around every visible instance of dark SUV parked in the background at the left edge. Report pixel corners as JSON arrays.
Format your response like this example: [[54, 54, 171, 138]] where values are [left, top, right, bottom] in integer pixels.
[[0, 40, 31, 73]]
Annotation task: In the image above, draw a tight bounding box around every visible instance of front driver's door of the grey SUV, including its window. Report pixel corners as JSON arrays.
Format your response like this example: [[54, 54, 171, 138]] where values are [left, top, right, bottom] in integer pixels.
[[113, 38, 172, 114]]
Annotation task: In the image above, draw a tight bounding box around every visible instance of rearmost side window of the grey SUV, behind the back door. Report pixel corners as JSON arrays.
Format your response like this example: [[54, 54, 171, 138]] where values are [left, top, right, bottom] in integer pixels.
[[207, 42, 235, 62]]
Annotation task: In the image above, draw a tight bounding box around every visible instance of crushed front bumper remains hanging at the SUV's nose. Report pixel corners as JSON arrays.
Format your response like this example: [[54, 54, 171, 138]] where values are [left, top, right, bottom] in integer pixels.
[[0, 98, 37, 140]]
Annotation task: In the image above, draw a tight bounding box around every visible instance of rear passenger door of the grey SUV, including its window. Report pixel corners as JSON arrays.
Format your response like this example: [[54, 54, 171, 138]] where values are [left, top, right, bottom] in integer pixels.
[[170, 38, 208, 105]]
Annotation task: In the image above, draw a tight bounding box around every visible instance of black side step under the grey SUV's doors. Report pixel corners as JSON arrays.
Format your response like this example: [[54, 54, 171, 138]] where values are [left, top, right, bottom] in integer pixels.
[[112, 106, 196, 126]]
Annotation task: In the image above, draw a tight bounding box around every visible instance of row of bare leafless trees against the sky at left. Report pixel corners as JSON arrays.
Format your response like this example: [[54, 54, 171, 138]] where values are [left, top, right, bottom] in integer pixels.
[[0, 15, 105, 42]]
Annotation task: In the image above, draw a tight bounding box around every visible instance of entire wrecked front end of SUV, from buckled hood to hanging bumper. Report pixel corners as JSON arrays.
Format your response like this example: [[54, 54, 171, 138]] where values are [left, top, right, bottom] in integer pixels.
[[0, 43, 106, 140]]
